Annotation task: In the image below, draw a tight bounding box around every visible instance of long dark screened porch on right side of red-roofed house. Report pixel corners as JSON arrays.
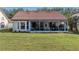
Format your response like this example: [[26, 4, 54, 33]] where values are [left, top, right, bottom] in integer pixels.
[[30, 21, 68, 31]]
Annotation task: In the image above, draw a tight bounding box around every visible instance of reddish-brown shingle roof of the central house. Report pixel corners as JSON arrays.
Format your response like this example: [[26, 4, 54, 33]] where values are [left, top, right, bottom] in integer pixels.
[[12, 11, 66, 21]]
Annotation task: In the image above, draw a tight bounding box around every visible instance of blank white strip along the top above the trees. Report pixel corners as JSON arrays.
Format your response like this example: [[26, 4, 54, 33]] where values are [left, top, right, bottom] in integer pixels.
[[0, 0, 79, 7]]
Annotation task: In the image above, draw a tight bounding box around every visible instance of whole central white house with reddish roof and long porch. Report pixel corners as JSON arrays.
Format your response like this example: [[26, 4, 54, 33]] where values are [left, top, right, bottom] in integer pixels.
[[12, 11, 68, 32]]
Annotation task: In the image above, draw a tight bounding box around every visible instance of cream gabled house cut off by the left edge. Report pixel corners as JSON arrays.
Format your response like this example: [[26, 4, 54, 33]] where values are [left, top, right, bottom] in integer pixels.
[[0, 9, 12, 30]]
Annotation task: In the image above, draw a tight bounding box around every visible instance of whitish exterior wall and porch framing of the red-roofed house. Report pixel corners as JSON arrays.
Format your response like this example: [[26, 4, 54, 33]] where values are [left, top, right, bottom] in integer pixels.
[[13, 21, 68, 32]]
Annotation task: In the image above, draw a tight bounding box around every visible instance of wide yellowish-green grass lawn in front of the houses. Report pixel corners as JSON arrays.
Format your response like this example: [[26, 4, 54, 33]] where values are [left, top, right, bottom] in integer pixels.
[[0, 32, 79, 51]]
